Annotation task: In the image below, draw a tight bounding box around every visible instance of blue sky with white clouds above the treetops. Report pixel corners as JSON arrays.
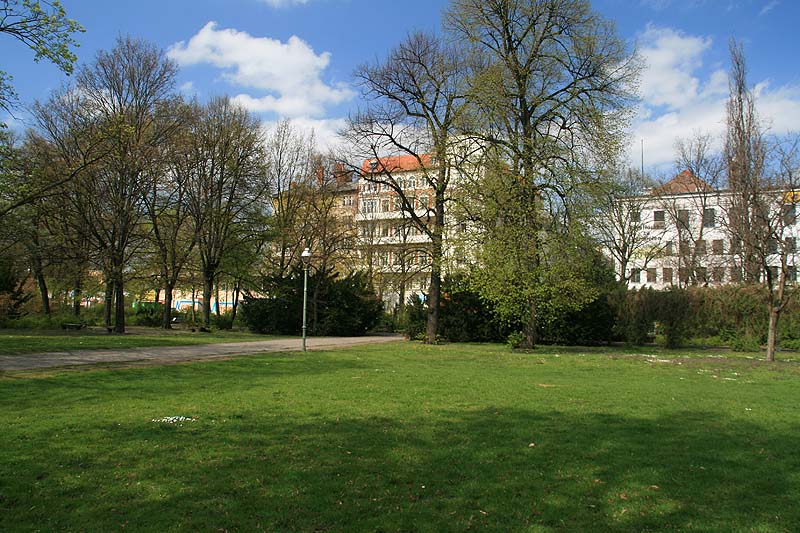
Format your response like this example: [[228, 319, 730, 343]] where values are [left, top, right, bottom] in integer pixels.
[[0, 0, 800, 172]]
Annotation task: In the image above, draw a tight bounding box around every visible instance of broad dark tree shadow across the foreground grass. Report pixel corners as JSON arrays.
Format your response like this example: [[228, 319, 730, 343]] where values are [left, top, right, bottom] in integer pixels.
[[0, 408, 800, 531]]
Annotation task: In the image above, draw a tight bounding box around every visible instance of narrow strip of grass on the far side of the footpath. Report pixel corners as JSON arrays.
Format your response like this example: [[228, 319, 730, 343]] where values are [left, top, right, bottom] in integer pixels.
[[0, 327, 280, 354]]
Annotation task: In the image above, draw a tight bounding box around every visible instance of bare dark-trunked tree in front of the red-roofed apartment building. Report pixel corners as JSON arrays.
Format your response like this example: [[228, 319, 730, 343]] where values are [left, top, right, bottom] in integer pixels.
[[346, 33, 467, 343]]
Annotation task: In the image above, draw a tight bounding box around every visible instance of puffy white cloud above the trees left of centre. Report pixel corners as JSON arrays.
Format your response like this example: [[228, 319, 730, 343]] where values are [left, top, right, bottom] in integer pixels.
[[168, 22, 353, 117]]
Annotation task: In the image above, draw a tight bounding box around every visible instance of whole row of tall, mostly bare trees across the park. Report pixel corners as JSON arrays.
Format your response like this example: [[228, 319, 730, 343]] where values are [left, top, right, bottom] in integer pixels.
[[0, 0, 796, 362]]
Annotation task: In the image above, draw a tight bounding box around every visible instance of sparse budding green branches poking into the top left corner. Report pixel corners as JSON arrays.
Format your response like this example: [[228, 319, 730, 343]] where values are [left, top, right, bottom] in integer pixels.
[[0, 0, 84, 121]]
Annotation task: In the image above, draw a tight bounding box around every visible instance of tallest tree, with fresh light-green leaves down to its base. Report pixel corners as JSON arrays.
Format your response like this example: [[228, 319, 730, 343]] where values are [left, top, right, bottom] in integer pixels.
[[446, 0, 638, 346]]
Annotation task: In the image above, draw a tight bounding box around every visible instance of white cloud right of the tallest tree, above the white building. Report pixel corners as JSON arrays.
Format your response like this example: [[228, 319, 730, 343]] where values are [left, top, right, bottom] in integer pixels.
[[629, 25, 800, 170]]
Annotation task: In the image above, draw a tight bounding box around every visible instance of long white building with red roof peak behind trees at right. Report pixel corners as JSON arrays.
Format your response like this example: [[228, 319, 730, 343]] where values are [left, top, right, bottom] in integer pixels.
[[615, 171, 800, 289]]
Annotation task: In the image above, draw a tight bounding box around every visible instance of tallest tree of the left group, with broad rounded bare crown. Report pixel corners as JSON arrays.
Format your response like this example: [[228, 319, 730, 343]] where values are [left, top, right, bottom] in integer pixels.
[[34, 37, 178, 333]]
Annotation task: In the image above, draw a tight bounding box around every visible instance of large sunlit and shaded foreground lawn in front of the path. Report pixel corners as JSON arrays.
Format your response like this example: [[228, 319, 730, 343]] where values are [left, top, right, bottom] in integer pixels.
[[0, 343, 800, 531]]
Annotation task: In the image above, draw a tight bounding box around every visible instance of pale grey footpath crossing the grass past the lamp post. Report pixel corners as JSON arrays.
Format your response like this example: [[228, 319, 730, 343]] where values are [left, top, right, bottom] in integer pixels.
[[0, 335, 403, 371]]
